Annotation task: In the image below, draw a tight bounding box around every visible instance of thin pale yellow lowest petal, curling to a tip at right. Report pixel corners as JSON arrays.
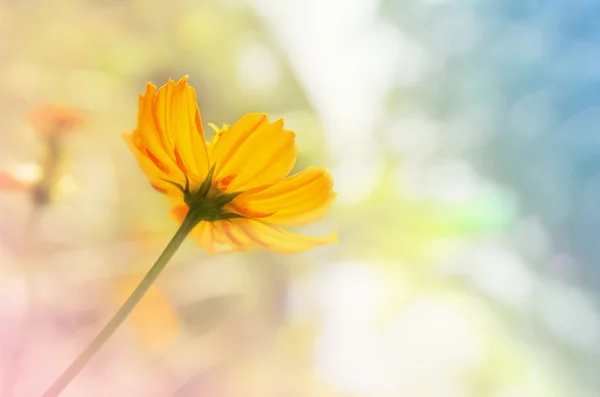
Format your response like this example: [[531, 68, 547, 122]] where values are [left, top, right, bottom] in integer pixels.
[[231, 219, 338, 254]]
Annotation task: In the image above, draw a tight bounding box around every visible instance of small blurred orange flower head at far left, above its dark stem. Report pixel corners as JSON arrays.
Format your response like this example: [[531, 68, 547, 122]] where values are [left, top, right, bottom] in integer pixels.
[[29, 103, 84, 136]]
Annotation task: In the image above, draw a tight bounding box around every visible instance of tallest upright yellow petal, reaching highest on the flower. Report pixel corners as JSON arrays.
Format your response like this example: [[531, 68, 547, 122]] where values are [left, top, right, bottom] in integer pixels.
[[152, 76, 209, 179]]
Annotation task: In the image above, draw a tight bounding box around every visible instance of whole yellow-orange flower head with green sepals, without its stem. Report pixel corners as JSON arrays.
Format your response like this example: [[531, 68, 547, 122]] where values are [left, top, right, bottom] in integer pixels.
[[123, 77, 337, 254]]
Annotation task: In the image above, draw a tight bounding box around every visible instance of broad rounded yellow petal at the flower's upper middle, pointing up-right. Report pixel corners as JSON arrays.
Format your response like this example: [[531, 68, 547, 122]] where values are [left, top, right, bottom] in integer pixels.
[[210, 113, 297, 192]]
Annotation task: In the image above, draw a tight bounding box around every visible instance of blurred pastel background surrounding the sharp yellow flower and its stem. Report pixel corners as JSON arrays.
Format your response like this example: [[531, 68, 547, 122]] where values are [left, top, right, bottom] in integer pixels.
[[0, 0, 600, 397]]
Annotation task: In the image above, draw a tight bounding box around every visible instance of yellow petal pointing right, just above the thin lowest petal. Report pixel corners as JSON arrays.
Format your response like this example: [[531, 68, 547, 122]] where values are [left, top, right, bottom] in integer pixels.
[[232, 167, 336, 226]]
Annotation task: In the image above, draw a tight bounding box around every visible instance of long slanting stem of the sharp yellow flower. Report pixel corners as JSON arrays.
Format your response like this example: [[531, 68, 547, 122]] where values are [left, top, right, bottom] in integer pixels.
[[42, 211, 201, 397]]
